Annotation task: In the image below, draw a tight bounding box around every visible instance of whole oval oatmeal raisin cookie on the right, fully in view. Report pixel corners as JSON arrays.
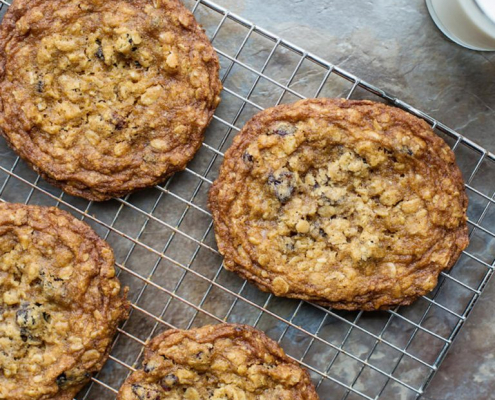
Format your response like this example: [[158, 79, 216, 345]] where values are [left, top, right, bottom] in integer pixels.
[[209, 99, 468, 310]]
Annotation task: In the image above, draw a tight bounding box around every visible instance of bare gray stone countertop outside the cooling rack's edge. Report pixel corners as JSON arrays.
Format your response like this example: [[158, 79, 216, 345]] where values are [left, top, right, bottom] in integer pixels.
[[216, 0, 495, 400]]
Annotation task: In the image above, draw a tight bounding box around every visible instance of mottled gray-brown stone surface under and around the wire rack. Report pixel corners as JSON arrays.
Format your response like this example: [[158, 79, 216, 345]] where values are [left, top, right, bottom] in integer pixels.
[[0, 0, 495, 400]]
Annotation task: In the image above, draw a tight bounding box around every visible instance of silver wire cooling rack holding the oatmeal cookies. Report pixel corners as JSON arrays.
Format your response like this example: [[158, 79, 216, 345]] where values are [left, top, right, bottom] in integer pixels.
[[0, 0, 495, 400]]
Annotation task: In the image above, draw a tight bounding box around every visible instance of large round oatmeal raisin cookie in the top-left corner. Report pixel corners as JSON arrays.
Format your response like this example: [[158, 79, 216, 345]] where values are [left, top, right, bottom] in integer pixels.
[[0, 0, 221, 201]]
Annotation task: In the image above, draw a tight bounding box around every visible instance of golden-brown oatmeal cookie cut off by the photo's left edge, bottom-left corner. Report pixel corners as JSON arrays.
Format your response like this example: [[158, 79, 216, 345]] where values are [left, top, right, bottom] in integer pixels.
[[0, 204, 128, 400]]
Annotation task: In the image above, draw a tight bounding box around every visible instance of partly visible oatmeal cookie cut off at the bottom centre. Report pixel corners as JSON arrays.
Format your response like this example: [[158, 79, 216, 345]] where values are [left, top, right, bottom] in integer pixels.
[[117, 324, 318, 400]]
